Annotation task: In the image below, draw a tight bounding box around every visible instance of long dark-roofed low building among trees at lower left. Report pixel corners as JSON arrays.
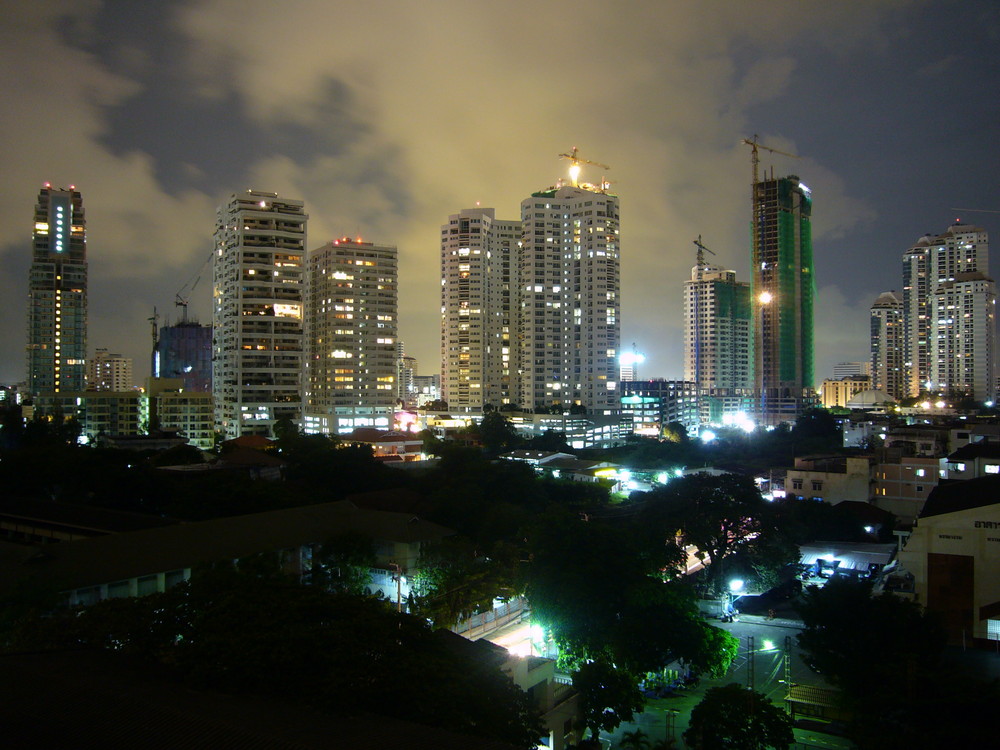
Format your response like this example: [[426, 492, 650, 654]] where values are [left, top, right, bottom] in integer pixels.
[[0, 501, 454, 605]]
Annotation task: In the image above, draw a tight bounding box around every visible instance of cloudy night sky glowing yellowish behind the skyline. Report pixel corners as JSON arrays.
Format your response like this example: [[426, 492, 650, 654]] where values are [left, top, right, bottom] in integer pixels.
[[0, 0, 1000, 382]]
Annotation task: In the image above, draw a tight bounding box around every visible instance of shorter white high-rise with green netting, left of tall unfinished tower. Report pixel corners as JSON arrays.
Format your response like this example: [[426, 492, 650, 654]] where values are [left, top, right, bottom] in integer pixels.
[[684, 264, 754, 393]]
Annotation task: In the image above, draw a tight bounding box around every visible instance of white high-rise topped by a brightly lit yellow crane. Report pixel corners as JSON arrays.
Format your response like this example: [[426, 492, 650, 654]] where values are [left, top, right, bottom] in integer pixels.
[[517, 184, 621, 414]]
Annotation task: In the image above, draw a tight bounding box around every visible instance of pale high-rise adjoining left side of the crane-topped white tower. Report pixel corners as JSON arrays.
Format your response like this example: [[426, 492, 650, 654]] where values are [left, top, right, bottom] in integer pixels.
[[441, 208, 521, 411]]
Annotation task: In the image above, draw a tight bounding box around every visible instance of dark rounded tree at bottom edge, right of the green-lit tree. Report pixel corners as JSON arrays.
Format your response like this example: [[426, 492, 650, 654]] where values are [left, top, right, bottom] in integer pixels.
[[684, 683, 795, 750]]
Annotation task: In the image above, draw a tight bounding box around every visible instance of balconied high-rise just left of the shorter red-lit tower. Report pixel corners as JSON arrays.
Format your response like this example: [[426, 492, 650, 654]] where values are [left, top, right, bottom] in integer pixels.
[[212, 190, 308, 439]]
